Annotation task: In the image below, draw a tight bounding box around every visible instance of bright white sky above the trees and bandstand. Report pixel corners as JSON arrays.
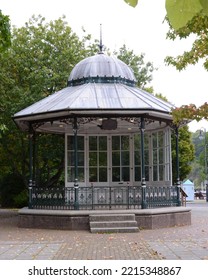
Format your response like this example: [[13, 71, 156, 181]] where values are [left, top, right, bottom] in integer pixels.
[[0, 0, 208, 131]]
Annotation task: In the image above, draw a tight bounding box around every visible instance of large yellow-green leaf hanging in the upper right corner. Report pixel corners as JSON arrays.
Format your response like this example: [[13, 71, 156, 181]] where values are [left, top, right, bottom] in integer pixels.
[[165, 0, 203, 30]]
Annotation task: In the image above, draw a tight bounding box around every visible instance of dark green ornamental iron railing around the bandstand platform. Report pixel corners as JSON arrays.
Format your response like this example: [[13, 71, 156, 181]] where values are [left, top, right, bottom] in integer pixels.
[[29, 186, 178, 210]]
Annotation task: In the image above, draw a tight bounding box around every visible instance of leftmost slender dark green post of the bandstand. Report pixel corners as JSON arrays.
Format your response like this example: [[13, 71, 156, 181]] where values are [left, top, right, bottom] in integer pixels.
[[28, 124, 33, 209]]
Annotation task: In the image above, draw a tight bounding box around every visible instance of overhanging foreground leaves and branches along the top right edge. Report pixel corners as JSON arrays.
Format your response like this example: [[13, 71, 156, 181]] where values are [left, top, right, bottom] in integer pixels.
[[124, 0, 208, 124]]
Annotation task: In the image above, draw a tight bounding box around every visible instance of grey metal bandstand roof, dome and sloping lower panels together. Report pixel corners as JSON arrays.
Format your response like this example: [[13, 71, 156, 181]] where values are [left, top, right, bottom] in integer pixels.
[[14, 53, 174, 133]]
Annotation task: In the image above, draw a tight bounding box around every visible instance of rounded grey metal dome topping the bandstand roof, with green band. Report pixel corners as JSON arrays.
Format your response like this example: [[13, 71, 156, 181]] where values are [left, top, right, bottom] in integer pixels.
[[68, 52, 136, 86]]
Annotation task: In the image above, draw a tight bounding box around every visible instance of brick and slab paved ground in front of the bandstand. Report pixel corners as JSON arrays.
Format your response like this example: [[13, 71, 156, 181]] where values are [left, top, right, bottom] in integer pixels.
[[0, 201, 208, 260]]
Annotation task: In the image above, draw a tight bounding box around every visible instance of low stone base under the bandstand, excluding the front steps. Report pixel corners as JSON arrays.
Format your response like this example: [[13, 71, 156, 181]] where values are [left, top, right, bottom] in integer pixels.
[[18, 207, 191, 230]]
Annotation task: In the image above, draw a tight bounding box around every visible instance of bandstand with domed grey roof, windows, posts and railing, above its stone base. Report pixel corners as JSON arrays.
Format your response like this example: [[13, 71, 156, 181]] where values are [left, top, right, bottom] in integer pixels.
[[14, 48, 190, 231]]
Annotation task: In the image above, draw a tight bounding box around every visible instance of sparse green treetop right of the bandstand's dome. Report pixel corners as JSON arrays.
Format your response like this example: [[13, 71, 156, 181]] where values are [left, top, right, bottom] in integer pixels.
[[114, 44, 155, 88]]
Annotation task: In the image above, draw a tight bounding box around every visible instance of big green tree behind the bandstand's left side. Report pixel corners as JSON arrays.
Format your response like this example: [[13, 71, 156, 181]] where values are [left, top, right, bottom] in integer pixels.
[[0, 16, 95, 208]]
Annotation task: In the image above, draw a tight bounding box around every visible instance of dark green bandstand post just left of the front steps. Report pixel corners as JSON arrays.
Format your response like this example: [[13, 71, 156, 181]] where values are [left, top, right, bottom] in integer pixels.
[[73, 117, 79, 210]]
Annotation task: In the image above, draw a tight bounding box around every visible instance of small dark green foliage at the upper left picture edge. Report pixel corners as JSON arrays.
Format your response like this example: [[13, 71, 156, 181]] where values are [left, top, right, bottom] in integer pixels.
[[0, 10, 11, 52]]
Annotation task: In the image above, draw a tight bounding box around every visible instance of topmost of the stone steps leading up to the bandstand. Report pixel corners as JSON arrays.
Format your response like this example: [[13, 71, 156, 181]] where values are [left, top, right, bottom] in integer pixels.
[[89, 214, 135, 222]]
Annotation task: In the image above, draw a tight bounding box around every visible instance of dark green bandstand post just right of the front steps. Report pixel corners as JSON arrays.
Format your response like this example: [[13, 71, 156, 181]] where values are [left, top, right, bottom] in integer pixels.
[[140, 117, 147, 209]]
